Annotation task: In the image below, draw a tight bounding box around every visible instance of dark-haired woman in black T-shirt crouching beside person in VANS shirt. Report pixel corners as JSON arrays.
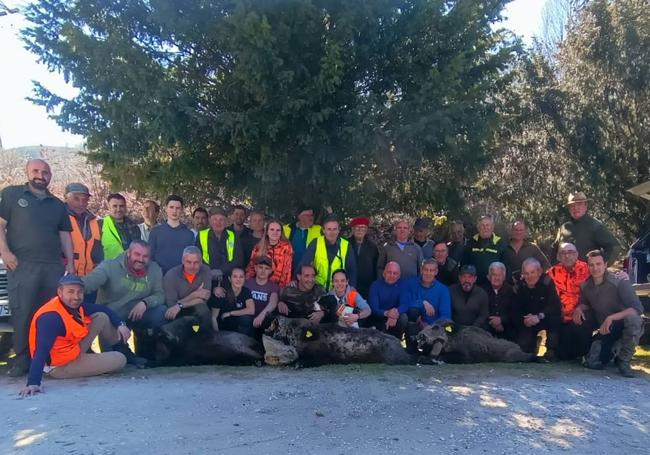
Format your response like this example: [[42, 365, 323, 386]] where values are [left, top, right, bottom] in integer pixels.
[[212, 267, 255, 336]]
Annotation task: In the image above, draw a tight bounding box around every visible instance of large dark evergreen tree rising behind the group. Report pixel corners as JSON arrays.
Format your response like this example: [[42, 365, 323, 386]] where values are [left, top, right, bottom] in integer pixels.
[[24, 0, 516, 215]]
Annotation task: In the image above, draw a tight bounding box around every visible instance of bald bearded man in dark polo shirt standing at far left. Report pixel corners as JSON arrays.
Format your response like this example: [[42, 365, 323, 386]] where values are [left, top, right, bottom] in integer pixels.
[[0, 160, 74, 376]]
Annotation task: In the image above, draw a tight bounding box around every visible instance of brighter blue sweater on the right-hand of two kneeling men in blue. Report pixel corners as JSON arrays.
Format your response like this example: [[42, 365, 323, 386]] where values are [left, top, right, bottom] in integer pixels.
[[399, 277, 451, 325]]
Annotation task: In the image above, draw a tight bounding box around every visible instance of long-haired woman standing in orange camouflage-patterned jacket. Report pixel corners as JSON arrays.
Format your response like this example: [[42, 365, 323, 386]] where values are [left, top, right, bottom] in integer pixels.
[[246, 220, 293, 288]]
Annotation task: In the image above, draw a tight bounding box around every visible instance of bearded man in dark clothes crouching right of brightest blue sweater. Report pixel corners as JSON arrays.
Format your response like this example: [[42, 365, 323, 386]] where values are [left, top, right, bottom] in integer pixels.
[[449, 264, 489, 329]]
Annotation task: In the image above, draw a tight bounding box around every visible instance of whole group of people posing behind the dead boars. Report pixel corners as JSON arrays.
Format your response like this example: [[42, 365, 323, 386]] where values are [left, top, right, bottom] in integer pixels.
[[0, 160, 643, 395]]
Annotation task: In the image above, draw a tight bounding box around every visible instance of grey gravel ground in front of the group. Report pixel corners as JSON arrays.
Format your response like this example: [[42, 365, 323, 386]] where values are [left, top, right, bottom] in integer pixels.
[[0, 364, 650, 455]]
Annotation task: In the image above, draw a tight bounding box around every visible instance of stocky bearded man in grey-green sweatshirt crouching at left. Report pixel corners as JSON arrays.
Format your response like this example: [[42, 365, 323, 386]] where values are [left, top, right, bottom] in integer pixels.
[[83, 240, 167, 367]]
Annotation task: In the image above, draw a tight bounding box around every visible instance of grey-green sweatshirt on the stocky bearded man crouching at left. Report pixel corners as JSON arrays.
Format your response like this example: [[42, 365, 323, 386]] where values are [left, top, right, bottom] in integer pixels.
[[83, 253, 165, 321]]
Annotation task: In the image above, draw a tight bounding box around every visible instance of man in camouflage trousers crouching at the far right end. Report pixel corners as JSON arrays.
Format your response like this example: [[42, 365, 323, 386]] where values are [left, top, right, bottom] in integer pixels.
[[573, 250, 643, 378]]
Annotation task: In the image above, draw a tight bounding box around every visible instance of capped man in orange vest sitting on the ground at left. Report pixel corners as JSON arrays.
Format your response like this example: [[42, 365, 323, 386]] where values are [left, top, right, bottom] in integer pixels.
[[20, 275, 131, 397]]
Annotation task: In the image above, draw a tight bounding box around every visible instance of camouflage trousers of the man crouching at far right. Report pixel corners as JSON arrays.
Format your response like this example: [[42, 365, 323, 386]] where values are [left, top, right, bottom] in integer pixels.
[[585, 315, 643, 366]]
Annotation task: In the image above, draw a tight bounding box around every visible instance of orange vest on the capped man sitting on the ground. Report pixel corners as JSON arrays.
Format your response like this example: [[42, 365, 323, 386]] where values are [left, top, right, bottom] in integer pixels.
[[29, 297, 91, 367]]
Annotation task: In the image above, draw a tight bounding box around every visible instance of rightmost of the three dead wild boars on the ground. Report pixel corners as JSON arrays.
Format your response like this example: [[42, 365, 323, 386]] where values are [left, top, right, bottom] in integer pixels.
[[416, 321, 535, 363]]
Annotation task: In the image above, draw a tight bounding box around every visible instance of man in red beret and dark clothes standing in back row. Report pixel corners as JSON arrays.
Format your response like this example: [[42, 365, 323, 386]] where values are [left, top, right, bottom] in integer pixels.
[[348, 217, 379, 299]]
